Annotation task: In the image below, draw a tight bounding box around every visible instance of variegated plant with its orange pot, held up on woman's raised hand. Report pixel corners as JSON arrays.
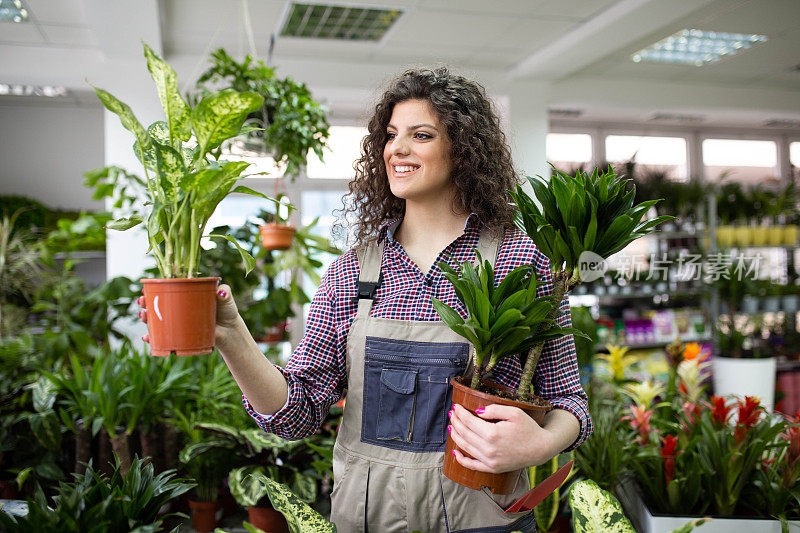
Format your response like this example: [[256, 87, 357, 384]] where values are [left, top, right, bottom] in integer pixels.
[[95, 45, 280, 356]]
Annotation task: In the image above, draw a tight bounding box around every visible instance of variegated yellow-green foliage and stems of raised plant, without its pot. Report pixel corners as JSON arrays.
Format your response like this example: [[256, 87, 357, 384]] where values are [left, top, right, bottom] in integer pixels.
[[95, 45, 276, 278]]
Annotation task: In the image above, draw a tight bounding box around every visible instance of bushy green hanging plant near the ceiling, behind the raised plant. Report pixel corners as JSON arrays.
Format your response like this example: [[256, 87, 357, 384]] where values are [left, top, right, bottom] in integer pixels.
[[192, 48, 329, 179]]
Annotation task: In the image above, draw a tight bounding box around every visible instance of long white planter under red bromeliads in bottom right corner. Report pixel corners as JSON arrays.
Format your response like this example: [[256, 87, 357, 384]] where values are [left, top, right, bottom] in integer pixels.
[[615, 481, 800, 533]]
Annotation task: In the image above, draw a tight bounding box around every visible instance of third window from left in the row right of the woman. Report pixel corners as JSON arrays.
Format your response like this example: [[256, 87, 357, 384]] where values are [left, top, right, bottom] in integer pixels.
[[703, 139, 778, 185]]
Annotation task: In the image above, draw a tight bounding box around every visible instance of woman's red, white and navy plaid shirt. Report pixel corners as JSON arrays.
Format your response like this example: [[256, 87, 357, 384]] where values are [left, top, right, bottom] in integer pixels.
[[242, 214, 592, 449]]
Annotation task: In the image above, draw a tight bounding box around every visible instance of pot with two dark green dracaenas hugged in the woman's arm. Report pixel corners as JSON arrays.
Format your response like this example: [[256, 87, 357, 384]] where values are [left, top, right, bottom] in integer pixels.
[[433, 167, 674, 494]]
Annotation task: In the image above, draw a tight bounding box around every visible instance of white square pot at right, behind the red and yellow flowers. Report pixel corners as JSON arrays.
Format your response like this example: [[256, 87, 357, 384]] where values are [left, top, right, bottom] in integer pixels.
[[712, 357, 776, 412]]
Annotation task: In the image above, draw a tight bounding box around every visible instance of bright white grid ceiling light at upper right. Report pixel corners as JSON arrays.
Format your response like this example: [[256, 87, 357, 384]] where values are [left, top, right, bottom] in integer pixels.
[[631, 30, 767, 67]]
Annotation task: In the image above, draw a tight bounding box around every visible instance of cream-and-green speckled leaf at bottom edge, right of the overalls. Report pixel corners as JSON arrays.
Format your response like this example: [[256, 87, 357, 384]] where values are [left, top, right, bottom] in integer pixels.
[[569, 480, 635, 533]]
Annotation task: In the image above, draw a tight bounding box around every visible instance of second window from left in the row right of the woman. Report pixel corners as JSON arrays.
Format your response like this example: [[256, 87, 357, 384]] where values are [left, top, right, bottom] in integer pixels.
[[606, 135, 688, 181]]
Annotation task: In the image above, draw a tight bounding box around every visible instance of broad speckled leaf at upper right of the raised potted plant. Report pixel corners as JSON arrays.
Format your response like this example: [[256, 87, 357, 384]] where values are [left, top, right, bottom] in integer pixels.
[[192, 89, 264, 159]]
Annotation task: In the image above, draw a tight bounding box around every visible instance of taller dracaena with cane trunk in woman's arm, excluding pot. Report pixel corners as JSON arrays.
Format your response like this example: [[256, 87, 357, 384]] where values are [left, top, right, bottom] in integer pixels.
[[510, 167, 675, 395]]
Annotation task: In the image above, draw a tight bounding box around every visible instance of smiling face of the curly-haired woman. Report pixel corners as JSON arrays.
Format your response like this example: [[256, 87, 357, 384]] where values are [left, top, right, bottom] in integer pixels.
[[383, 100, 454, 207]]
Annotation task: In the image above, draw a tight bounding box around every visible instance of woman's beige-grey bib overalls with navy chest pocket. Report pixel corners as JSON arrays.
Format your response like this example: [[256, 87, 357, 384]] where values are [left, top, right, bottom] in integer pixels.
[[331, 230, 536, 533]]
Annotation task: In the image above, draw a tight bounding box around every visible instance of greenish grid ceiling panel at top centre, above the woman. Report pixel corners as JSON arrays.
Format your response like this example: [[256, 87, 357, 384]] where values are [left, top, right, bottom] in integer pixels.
[[281, 3, 403, 41]]
